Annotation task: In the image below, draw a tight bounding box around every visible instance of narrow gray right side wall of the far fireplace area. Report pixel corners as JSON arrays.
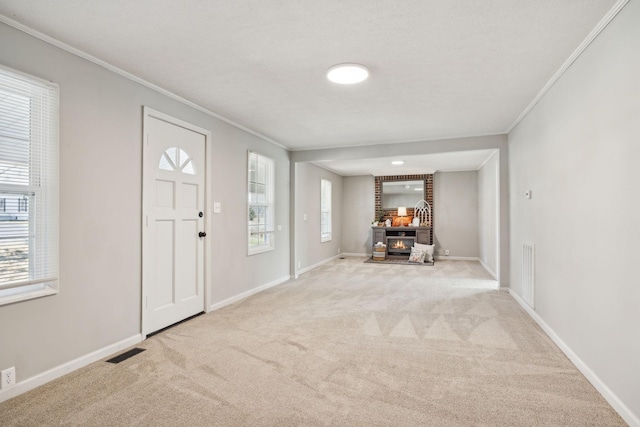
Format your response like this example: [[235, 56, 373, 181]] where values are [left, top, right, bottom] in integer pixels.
[[478, 152, 500, 280]]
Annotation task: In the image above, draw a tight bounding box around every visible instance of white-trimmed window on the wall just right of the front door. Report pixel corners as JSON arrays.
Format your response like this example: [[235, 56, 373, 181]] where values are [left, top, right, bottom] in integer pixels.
[[247, 151, 275, 255]]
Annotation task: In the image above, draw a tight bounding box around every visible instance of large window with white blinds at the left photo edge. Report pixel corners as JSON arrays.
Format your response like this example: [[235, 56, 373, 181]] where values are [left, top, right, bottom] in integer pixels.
[[0, 67, 58, 304]]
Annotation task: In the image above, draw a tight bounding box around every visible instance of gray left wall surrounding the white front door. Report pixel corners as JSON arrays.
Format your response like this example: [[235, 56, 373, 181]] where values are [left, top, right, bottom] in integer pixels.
[[0, 24, 289, 382]]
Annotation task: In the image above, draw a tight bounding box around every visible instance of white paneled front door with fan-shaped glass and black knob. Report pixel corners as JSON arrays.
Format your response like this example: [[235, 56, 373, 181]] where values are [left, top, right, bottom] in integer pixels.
[[142, 108, 206, 336]]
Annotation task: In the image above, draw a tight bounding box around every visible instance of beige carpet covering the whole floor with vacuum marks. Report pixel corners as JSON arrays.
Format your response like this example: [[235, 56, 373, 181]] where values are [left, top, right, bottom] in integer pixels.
[[0, 258, 626, 427]]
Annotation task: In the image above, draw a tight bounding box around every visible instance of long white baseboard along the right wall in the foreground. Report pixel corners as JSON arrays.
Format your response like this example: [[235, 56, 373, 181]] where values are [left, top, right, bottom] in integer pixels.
[[505, 289, 640, 427]]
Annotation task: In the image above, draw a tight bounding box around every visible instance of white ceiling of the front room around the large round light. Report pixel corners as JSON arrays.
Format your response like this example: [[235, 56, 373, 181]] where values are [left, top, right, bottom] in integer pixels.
[[0, 0, 616, 174]]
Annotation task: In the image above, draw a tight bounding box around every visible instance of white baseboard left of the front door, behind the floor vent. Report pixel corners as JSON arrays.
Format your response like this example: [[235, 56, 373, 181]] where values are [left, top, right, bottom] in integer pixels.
[[0, 334, 142, 402]]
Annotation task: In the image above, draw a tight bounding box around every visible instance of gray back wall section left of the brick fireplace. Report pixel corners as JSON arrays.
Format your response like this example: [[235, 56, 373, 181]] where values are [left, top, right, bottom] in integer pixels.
[[342, 175, 377, 255]]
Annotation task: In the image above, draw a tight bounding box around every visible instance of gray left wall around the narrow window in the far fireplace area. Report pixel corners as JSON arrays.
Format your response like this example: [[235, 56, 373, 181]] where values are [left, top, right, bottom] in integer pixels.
[[295, 163, 343, 270]]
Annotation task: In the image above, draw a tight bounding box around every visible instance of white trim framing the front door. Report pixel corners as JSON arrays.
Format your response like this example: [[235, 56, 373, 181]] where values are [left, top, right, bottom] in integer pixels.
[[140, 106, 213, 340]]
